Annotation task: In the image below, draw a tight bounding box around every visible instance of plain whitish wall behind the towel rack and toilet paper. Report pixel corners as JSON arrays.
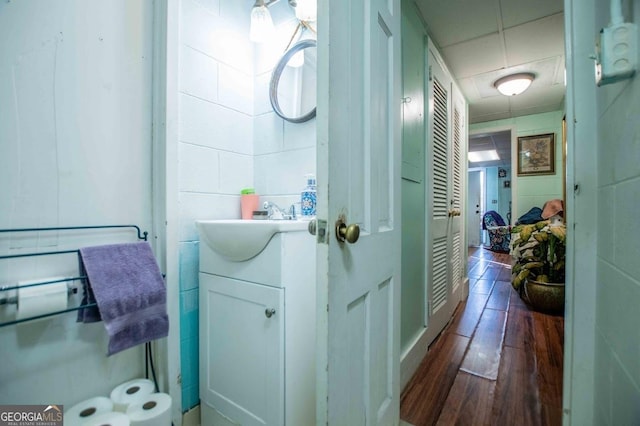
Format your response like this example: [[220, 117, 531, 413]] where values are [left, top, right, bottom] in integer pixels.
[[0, 0, 153, 408]]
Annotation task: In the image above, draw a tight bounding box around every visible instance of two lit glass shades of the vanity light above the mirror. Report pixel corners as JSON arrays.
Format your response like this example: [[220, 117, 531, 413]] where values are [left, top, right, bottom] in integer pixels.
[[249, 0, 318, 43]]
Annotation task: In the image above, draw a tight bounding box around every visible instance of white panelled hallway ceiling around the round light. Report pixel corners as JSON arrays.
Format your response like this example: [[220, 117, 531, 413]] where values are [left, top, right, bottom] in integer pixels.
[[414, 0, 565, 123]]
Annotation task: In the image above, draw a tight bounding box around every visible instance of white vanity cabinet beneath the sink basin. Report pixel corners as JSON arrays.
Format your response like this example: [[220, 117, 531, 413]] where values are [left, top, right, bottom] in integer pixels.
[[199, 223, 316, 426]]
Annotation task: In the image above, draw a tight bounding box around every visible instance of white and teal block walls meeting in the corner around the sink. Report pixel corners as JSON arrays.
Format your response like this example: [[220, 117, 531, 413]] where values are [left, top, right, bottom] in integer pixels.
[[178, 0, 315, 411]]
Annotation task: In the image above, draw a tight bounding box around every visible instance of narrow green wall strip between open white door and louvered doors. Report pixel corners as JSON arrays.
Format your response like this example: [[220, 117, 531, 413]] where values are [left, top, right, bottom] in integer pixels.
[[400, 2, 426, 351]]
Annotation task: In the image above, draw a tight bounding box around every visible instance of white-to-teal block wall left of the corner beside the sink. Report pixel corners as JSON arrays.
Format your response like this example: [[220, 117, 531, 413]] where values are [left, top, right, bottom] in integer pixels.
[[178, 0, 253, 411]]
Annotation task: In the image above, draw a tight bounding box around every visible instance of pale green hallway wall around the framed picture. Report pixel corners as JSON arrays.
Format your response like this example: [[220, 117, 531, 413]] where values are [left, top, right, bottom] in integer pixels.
[[469, 111, 564, 218]]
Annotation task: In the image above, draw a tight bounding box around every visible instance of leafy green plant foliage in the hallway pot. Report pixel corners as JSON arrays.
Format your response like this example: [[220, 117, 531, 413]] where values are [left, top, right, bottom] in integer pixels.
[[511, 220, 567, 292]]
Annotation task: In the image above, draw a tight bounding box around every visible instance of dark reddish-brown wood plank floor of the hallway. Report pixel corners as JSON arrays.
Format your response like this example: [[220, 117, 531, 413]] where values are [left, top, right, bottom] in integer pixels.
[[400, 248, 564, 426]]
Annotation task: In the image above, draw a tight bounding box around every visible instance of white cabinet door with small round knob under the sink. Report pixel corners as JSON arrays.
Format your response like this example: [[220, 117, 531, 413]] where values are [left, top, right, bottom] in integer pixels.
[[200, 273, 284, 426]]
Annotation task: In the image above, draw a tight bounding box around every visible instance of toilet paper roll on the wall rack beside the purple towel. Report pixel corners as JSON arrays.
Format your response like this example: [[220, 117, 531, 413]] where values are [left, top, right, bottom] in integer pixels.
[[16, 277, 68, 319]]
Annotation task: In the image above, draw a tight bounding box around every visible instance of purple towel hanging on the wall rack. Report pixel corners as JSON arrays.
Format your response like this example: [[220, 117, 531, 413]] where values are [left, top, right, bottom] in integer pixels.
[[78, 242, 169, 355]]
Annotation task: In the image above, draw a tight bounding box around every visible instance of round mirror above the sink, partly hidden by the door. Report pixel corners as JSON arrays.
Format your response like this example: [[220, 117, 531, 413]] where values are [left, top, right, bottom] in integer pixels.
[[269, 39, 317, 123]]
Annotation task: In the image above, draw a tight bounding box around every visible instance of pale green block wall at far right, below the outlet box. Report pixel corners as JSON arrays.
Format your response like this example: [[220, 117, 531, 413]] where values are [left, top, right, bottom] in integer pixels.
[[592, 1, 640, 425]]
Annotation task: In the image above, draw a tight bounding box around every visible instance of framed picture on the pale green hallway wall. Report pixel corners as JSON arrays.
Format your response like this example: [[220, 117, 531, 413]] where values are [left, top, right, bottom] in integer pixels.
[[518, 133, 555, 176]]
